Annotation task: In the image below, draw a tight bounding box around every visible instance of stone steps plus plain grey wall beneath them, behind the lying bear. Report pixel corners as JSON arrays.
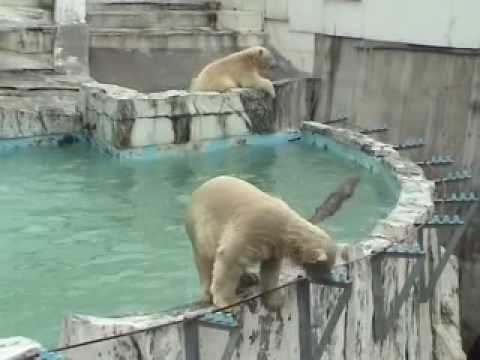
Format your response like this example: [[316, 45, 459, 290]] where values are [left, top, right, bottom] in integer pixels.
[[87, 0, 264, 92]]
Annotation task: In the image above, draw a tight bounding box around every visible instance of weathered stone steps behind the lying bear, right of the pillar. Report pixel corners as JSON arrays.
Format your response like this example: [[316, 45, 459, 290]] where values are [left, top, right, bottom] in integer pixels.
[[87, 0, 263, 50]]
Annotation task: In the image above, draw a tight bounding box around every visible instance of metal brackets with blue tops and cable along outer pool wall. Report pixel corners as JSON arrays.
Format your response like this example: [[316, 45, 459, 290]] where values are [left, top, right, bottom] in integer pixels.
[[0, 121, 468, 360]]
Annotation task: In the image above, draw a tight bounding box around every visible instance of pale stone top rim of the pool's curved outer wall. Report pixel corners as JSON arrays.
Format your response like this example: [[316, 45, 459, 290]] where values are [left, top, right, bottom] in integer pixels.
[[0, 111, 433, 358]]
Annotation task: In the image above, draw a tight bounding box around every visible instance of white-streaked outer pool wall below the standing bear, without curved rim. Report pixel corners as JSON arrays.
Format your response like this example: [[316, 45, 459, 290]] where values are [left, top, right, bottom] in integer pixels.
[[61, 232, 465, 360]]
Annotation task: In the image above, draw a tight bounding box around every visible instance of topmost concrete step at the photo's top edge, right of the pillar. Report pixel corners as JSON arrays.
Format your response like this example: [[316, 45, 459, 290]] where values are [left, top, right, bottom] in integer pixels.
[[87, 0, 220, 13]]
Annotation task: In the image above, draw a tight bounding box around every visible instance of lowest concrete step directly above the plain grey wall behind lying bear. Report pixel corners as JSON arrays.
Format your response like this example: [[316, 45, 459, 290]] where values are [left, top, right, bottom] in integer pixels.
[[90, 28, 264, 51]]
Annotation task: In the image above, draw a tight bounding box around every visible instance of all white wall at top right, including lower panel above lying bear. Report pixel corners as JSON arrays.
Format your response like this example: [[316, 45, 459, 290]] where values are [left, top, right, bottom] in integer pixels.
[[216, 0, 480, 73]]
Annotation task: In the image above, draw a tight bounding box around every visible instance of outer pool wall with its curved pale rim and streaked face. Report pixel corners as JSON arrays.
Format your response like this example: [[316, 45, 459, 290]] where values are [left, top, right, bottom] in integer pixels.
[[55, 123, 464, 360]]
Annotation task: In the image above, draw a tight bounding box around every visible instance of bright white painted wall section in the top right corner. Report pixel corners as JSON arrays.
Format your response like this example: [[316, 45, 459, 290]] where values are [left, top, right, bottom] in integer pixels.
[[288, 0, 480, 48]]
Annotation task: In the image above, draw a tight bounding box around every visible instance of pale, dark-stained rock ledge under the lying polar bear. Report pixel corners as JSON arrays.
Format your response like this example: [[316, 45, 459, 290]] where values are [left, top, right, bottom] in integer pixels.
[[81, 79, 318, 155]]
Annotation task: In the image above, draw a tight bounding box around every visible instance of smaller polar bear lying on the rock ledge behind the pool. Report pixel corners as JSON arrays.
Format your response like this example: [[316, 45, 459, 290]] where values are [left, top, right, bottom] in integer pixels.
[[191, 46, 276, 97]]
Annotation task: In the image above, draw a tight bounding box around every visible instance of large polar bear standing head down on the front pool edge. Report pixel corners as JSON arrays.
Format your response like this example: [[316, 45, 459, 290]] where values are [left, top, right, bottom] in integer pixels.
[[185, 176, 336, 310]]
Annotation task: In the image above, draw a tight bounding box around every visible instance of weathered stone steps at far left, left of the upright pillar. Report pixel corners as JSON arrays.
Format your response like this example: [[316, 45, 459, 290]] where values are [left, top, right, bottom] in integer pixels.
[[0, 0, 86, 143]]
